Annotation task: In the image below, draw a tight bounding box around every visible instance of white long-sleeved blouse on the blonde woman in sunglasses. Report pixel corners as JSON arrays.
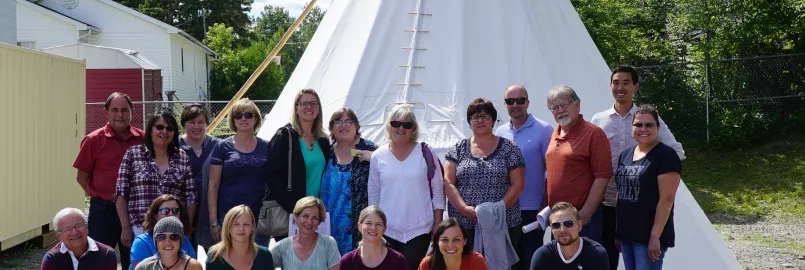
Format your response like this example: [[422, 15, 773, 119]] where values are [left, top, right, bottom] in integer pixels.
[[368, 144, 445, 243]]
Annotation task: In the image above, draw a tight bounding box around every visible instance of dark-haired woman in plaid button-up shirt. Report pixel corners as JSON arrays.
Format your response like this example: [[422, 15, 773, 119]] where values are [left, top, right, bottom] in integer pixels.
[[113, 112, 197, 247]]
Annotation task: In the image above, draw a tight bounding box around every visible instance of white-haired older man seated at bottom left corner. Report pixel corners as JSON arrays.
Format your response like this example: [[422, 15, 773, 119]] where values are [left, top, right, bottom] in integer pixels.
[[42, 208, 117, 270]]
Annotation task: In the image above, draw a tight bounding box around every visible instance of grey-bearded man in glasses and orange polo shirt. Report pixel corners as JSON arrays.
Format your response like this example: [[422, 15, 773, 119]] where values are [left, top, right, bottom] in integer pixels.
[[545, 85, 612, 242]]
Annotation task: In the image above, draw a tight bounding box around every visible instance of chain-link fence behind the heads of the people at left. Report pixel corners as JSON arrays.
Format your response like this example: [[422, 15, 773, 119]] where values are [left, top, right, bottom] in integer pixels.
[[86, 100, 275, 137]]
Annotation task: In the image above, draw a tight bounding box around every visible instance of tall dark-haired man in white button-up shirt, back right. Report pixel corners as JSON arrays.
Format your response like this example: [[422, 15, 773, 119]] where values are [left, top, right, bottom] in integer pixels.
[[591, 65, 685, 269]]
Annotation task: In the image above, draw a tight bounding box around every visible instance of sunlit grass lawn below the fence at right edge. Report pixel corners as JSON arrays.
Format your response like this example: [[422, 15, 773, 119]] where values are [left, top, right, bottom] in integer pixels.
[[682, 136, 805, 218]]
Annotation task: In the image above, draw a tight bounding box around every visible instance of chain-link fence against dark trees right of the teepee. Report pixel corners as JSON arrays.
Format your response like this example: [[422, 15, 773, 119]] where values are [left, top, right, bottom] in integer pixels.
[[637, 54, 805, 146]]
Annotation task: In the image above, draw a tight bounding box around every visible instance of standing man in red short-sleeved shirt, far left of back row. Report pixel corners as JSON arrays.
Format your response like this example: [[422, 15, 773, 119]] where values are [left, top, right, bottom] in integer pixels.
[[73, 92, 144, 269]]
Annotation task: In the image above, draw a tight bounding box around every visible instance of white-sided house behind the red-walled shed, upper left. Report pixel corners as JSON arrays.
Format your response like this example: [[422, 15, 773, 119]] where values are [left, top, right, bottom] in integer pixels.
[[16, 0, 216, 100]]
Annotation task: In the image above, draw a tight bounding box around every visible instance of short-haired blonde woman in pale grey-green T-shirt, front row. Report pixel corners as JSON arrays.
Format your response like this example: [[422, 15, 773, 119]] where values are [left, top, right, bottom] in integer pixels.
[[271, 196, 341, 270]]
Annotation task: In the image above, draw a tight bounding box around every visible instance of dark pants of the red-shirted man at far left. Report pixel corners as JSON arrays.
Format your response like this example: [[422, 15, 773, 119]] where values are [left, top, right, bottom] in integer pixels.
[[87, 197, 131, 270]]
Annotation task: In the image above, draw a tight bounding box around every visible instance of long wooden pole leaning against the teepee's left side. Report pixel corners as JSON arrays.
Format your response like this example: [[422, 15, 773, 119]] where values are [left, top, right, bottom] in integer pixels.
[[207, 0, 318, 134]]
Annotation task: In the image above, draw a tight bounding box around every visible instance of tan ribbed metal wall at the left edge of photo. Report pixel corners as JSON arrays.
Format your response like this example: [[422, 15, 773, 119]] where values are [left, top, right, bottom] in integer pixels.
[[0, 44, 86, 245]]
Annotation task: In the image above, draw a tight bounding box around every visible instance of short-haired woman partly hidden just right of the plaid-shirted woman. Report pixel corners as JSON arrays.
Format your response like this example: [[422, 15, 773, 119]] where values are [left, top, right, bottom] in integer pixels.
[[179, 104, 218, 249]]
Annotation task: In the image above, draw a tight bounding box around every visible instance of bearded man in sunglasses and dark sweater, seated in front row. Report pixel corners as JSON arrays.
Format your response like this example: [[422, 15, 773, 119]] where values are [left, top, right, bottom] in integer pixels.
[[531, 202, 610, 270]]
